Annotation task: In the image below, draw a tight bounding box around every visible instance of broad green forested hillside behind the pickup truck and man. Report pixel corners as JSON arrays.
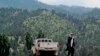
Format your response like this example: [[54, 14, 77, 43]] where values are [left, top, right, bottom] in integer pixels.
[[0, 8, 100, 56]]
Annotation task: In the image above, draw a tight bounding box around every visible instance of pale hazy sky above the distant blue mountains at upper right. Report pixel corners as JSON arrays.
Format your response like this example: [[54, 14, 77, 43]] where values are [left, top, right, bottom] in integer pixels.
[[38, 0, 100, 8]]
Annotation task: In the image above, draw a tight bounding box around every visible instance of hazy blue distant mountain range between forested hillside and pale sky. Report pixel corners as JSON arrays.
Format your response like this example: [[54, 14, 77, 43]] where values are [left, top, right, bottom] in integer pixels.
[[0, 0, 92, 15]]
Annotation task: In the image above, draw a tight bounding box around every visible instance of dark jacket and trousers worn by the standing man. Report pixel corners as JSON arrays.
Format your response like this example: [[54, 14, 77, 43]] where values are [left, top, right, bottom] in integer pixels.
[[67, 36, 75, 56]]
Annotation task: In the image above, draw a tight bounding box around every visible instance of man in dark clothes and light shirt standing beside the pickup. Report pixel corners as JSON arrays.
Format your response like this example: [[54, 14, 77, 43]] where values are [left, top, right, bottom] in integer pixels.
[[67, 33, 75, 56]]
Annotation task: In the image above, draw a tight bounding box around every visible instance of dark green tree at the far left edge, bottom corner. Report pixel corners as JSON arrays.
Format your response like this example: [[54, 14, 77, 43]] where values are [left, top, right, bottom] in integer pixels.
[[0, 34, 10, 56]]
